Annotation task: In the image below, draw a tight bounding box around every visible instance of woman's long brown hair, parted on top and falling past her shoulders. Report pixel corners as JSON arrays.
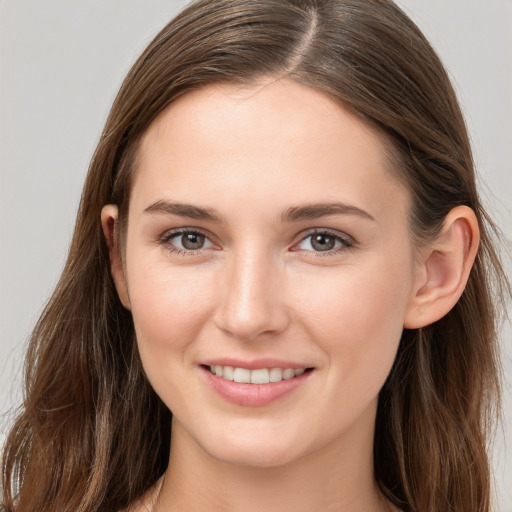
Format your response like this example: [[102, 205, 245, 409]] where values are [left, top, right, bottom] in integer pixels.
[[3, 0, 507, 512]]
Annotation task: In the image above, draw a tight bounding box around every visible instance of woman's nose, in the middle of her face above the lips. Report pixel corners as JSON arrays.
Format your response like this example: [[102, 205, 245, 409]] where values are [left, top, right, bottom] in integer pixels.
[[215, 251, 290, 340]]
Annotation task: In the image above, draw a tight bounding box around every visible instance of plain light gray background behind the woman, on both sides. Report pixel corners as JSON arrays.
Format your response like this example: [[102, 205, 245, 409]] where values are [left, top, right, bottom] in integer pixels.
[[0, 0, 512, 512]]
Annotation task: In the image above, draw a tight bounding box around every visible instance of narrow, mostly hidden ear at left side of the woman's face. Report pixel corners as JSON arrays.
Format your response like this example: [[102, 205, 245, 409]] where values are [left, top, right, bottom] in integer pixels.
[[101, 204, 130, 310]]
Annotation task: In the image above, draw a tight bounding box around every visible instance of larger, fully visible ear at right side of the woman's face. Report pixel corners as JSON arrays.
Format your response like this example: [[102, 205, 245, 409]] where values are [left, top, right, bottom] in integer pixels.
[[404, 206, 480, 329]]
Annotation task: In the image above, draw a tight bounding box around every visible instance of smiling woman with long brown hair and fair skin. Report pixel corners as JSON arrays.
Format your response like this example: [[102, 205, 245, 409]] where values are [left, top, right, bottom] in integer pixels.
[[0, 0, 506, 512]]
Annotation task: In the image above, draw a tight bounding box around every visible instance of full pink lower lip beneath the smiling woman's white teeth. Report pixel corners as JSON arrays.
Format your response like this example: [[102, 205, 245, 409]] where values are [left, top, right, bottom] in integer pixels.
[[202, 367, 313, 407]]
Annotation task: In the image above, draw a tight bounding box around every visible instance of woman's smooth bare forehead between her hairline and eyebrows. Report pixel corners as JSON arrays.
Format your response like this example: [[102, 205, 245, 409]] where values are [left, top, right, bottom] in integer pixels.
[[133, 79, 407, 222]]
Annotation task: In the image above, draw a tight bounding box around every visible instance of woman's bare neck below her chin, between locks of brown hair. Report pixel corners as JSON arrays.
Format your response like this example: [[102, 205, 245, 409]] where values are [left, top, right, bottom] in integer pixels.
[[155, 406, 389, 512]]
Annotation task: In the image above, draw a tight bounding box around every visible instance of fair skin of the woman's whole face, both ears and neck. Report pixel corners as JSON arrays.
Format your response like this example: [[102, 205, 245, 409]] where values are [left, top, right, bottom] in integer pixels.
[[102, 80, 478, 512]]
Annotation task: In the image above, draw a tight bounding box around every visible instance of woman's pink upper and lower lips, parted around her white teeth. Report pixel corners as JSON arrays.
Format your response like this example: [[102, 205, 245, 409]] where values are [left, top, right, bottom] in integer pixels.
[[200, 359, 312, 407]]
